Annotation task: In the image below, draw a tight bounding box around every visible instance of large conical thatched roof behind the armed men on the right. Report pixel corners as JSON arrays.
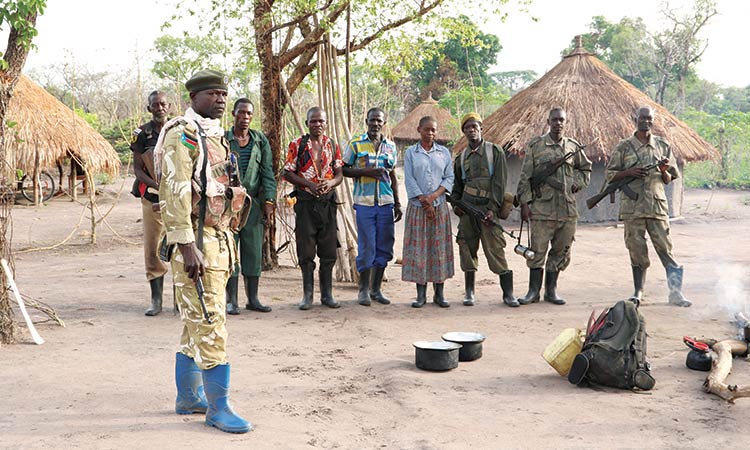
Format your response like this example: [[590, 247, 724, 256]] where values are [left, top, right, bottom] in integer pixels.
[[454, 38, 719, 162]]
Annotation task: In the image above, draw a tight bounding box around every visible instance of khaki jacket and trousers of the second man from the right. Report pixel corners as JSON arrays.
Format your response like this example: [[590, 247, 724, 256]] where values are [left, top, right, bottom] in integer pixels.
[[517, 134, 591, 272]]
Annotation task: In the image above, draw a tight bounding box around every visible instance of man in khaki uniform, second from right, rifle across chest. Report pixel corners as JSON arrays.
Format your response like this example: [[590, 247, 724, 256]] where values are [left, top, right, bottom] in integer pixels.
[[516, 108, 591, 305]]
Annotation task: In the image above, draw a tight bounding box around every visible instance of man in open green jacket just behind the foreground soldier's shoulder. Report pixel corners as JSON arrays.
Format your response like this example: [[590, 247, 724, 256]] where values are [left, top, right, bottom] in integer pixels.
[[226, 98, 276, 315]]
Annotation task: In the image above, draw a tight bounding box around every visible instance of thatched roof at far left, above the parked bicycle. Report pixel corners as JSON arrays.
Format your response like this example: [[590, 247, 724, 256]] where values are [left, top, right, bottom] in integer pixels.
[[6, 75, 120, 176]]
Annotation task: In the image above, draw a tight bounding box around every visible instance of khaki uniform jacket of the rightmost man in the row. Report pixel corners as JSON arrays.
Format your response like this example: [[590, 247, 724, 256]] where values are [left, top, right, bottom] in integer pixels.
[[607, 134, 680, 220]]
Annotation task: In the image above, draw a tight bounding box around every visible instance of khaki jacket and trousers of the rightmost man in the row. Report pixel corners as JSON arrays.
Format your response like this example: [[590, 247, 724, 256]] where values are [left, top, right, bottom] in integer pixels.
[[607, 130, 679, 270]]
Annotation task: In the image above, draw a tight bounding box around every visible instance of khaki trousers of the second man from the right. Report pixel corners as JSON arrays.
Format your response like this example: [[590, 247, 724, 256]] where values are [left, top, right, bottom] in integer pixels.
[[526, 218, 578, 272]]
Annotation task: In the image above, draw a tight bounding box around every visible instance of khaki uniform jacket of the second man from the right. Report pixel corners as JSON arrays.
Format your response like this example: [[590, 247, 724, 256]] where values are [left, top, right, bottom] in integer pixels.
[[516, 134, 591, 220]]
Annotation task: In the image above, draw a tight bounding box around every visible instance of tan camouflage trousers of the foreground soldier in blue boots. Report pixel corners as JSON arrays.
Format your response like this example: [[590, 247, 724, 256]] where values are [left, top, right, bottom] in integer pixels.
[[172, 227, 237, 370]]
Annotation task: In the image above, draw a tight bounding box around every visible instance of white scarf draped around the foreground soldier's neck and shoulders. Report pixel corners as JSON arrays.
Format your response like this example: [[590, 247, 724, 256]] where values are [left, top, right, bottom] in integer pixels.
[[154, 108, 224, 197]]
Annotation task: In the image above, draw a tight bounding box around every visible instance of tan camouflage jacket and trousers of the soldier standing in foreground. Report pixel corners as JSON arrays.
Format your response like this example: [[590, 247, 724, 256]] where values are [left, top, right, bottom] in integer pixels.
[[159, 121, 241, 370]]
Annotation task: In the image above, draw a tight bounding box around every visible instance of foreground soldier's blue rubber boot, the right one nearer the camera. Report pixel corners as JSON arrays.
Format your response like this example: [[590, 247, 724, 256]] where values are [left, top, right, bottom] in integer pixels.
[[203, 364, 253, 433]]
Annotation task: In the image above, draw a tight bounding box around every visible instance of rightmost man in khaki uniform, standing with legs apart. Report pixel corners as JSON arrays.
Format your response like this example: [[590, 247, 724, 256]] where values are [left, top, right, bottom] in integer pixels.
[[607, 106, 692, 307]]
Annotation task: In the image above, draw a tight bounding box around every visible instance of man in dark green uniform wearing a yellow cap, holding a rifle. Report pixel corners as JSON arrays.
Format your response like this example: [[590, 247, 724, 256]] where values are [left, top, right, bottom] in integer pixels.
[[451, 113, 519, 307]]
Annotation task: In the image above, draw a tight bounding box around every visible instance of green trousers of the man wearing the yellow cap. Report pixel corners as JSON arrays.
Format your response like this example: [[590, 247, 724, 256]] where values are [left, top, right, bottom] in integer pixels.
[[456, 214, 510, 275]]
